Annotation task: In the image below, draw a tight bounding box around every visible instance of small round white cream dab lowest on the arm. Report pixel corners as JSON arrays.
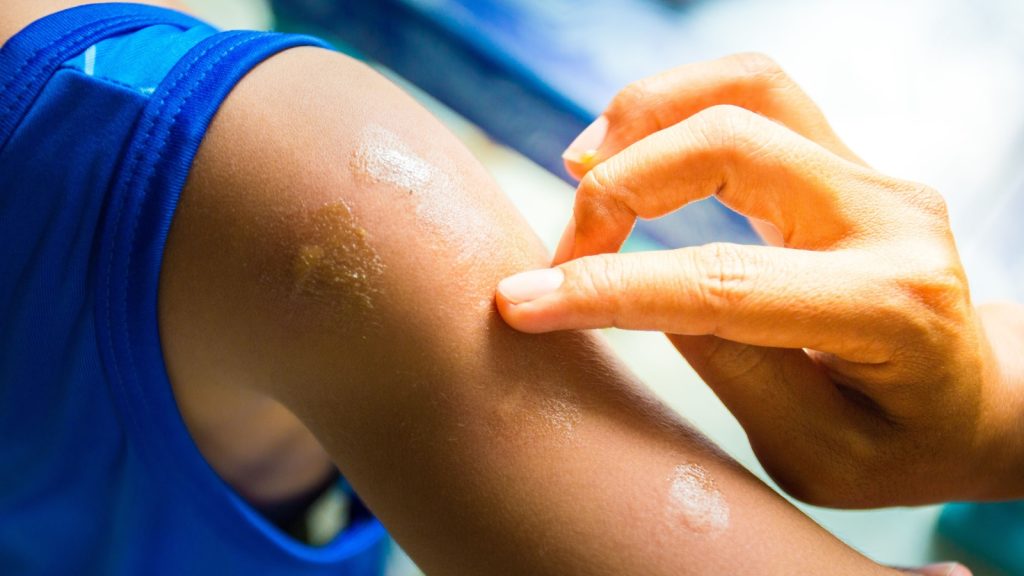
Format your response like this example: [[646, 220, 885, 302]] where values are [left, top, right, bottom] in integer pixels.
[[669, 464, 729, 533]]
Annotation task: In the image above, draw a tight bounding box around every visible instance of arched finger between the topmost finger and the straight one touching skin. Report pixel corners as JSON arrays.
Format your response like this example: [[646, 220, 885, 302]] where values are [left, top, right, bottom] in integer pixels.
[[555, 107, 885, 264]]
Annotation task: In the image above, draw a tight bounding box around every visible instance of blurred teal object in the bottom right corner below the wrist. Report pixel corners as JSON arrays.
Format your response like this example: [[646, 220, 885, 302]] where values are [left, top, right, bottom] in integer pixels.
[[939, 502, 1024, 574]]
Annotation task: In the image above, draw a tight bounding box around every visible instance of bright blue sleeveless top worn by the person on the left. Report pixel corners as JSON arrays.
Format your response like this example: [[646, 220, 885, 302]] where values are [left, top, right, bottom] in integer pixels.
[[0, 4, 388, 576]]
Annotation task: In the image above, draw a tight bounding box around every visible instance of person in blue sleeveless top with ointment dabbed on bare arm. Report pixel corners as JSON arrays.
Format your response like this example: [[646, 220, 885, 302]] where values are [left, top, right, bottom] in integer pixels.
[[0, 0, 966, 575]]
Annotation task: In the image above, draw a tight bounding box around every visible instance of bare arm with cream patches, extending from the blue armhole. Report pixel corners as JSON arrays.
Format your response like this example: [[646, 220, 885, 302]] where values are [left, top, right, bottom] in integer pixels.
[[160, 49, 882, 574]]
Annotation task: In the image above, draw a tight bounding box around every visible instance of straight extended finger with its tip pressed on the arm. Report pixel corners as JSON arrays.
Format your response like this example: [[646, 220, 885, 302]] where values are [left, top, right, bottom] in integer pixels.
[[496, 243, 864, 360]]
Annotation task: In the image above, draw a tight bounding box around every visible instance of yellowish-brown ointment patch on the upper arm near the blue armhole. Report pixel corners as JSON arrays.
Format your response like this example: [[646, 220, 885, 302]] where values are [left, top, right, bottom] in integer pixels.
[[292, 201, 384, 316]]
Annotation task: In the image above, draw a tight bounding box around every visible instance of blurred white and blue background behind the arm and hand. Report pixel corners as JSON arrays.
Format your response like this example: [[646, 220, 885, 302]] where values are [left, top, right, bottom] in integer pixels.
[[187, 0, 1024, 576]]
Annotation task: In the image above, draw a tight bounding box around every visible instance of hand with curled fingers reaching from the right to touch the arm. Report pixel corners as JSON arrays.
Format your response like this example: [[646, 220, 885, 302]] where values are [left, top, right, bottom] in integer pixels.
[[497, 54, 1024, 507]]
